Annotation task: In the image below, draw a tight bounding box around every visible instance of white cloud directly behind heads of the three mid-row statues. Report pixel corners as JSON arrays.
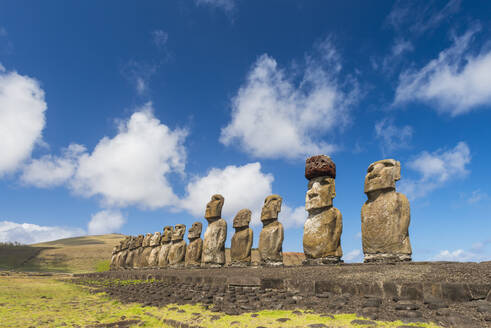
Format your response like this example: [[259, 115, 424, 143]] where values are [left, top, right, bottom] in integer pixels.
[[180, 163, 272, 224]]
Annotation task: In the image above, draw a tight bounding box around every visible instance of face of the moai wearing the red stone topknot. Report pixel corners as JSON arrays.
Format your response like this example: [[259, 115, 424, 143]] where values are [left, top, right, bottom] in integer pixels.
[[305, 177, 336, 211]]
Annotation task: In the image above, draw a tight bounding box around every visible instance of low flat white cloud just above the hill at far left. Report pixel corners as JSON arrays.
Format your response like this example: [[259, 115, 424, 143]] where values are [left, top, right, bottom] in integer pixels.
[[0, 221, 86, 244]]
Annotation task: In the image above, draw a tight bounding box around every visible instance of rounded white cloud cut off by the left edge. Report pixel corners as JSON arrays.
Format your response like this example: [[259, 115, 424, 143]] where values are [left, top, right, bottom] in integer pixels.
[[0, 66, 47, 176]]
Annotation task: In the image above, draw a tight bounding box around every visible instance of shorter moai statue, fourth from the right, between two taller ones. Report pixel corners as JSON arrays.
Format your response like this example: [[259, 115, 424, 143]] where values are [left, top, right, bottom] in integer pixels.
[[230, 209, 253, 266]]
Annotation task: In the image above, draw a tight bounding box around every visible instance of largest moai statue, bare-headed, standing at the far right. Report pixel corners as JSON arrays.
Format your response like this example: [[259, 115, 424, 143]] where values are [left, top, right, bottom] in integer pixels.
[[361, 159, 412, 263]]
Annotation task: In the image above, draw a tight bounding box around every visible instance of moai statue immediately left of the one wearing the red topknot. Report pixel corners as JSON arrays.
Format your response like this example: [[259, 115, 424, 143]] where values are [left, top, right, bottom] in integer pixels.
[[259, 195, 284, 266]]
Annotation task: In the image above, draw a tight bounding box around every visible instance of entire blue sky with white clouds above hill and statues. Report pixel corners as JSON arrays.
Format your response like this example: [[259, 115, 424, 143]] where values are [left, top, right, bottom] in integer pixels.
[[0, 0, 491, 261]]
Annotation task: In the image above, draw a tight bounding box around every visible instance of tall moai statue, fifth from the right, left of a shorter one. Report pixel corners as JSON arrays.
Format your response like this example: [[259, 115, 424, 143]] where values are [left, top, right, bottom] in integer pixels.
[[203, 194, 227, 267]]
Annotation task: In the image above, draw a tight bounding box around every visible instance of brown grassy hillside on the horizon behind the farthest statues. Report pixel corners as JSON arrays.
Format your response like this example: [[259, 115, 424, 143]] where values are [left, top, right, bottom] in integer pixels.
[[0, 234, 123, 273]]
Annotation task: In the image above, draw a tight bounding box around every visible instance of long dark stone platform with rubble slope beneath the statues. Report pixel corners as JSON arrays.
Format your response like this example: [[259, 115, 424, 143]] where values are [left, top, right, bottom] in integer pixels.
[[76, 262, 491, 328]]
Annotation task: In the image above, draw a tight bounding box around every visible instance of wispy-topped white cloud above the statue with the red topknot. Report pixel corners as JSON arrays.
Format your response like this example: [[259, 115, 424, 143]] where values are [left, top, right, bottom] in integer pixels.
[[220, 39, 357, 158]]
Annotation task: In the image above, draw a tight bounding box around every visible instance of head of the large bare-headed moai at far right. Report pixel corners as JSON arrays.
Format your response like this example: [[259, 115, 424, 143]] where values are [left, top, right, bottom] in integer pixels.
[[365, 159, 401, 194]]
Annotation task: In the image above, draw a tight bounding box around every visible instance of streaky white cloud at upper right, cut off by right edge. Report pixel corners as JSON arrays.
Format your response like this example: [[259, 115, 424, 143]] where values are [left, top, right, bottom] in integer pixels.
[[394, 27, 491, 116]]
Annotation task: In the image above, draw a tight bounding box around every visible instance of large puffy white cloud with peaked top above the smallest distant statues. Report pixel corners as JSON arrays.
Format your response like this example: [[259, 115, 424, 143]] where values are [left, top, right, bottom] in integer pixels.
[[70, 103, 187, 208]]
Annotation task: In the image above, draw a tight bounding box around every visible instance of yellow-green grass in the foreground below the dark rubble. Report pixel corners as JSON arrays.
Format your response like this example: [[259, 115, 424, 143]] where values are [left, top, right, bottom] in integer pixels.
[[0, 275, 438, 328]]
